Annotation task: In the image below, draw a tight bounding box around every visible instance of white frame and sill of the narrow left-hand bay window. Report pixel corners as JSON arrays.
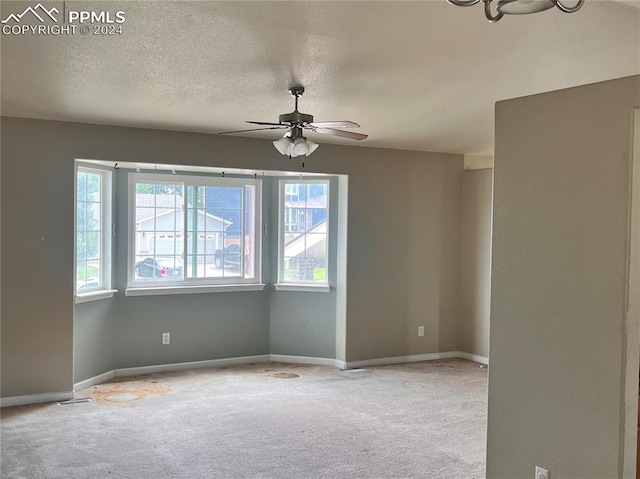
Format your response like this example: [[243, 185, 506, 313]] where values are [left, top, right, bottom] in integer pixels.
[[73, 165, 117, 303]]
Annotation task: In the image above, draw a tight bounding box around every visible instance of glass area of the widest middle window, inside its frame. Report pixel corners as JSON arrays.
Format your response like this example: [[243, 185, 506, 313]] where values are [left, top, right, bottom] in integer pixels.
[[132, 175, 259, 284]]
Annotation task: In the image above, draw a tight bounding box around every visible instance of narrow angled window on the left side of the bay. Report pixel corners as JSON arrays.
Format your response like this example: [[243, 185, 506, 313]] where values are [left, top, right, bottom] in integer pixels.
[[75, 165, 112, 296]]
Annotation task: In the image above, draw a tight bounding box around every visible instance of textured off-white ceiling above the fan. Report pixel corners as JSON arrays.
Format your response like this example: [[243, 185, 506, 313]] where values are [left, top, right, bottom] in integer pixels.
[[0, 0, 640, 155]]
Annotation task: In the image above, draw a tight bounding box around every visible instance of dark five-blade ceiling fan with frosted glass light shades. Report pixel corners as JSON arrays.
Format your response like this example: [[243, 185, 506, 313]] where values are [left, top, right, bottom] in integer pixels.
[[218, 86, 368, 157]]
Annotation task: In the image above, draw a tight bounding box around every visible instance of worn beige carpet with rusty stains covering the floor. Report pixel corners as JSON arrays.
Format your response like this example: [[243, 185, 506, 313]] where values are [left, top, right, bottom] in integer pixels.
[[0, 359, 487, 479]]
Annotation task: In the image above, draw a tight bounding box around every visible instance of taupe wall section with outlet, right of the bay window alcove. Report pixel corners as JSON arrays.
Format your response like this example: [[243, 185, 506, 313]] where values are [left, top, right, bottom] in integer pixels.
[[344, 158, 463, 361]]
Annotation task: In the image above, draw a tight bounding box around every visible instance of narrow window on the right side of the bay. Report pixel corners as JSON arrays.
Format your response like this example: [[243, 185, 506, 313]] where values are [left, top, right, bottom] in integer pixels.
[[278, 180, 329, 286]]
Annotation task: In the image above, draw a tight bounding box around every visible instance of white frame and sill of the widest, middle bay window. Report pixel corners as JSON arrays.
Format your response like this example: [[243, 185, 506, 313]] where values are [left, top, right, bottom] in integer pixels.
[[125, 172, 264, 290]]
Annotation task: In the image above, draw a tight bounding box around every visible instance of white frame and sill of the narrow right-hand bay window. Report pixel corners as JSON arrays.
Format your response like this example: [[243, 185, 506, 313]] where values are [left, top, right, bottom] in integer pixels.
[[275, 178, 331, 284]]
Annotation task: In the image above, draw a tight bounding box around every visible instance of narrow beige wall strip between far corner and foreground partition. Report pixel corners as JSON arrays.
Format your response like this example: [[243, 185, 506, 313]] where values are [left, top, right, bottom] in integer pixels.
[[460, 169, 493, 357]]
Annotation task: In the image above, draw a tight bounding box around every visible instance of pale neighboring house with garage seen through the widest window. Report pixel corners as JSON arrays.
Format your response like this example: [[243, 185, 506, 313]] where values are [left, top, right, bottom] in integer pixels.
[[136, 193, 232, 263]]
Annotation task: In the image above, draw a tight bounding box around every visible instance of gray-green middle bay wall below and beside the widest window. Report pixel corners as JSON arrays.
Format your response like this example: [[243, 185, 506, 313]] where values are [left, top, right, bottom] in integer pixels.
[[107, 169, 271, 374]]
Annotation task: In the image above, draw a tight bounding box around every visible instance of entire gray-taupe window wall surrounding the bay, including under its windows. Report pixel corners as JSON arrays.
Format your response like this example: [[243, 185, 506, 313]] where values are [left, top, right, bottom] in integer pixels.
[[1, 118, 463, 397]]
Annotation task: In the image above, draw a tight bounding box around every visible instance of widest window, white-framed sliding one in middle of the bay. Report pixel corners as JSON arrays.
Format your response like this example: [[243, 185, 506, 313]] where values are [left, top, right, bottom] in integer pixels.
[[128, 173, 261, 288]]
